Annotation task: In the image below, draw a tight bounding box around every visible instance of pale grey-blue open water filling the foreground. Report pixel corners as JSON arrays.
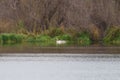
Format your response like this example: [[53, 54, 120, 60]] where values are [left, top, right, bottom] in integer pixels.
[[0, 53, 120, 80]]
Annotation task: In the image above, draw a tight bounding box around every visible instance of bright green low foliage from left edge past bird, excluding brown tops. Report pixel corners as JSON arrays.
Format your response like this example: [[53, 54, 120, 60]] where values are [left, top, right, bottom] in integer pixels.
[[0, 31, 91, 46]]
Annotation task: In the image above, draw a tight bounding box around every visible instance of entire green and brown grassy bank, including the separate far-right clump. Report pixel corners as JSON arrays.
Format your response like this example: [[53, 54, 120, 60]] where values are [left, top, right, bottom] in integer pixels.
[[0, 27, 120, 46]]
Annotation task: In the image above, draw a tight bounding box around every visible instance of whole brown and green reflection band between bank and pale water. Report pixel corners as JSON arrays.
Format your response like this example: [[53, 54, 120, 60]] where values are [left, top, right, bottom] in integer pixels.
[[0, 42, 120, 54]]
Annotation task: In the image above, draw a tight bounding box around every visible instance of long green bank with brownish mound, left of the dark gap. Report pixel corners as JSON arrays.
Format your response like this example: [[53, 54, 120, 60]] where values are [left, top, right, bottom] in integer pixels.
[[0, 28, 92, 46]]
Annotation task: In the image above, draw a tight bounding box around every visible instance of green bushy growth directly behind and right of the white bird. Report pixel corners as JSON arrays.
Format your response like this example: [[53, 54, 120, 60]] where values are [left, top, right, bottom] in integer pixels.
[[55, 32, 92, 46]]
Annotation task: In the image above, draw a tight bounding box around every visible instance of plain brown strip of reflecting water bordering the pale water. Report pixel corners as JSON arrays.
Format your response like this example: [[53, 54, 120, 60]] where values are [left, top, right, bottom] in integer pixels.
[[0, 47, 120, 54]]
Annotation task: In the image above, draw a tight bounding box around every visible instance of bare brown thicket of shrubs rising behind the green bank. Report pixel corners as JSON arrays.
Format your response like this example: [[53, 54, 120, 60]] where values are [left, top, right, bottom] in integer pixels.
[[0, 0, 120, 39]]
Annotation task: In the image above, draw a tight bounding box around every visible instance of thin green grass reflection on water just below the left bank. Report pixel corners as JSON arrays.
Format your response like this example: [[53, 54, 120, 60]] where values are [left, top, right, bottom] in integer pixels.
[[0, 41, 92, 47]]
